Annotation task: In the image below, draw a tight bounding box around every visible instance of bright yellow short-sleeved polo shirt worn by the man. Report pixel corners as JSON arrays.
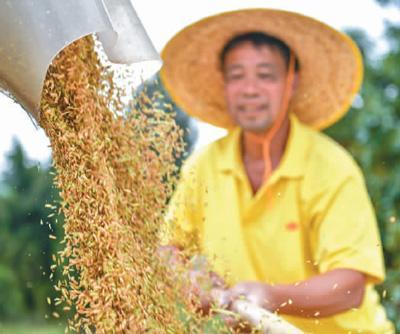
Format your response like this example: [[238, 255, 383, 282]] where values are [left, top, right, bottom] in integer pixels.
[[167, 116, 394, 334]]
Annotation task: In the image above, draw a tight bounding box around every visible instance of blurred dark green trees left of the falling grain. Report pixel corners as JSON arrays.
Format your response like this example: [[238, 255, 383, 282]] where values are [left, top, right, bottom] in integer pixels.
[[0, 142, 60, 320]]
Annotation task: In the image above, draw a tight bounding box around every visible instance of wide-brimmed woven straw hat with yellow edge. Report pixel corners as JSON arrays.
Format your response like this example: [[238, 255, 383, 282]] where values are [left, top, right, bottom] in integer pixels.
[[160, 9, 363, 129]]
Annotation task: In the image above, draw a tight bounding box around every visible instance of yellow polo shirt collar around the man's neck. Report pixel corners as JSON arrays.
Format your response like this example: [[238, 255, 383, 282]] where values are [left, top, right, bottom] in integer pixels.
[[218, 114, 310, 183]]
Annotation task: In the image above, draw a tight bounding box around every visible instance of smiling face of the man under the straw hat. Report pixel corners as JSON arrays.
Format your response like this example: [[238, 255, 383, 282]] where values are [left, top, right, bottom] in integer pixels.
[[223, 42, 287, 133]]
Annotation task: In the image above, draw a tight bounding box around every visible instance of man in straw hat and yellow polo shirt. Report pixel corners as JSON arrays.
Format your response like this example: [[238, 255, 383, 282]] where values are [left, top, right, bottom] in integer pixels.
[[161, 9, 394, 334]]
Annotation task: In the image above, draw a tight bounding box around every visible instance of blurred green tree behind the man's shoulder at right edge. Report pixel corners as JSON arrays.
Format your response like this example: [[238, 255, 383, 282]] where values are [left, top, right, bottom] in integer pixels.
[[326, 6, 400, 331]]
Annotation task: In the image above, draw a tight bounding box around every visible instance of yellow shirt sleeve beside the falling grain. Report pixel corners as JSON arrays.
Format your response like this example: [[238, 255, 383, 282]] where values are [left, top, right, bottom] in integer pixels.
[[161, 158, 202, 250]]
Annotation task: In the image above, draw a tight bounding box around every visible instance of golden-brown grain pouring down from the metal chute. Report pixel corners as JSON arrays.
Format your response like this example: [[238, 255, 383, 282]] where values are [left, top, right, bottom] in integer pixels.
[[41, 37, 208, 334]]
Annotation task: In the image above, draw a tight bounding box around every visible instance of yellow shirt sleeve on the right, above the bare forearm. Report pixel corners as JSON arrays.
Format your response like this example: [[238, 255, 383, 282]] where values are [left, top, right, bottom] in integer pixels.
[[312, 172, 385, 284]]
